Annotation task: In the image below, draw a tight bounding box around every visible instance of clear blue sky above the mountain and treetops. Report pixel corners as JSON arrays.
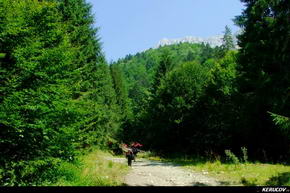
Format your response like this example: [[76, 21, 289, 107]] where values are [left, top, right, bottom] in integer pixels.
[[87, 0, 244, 62]]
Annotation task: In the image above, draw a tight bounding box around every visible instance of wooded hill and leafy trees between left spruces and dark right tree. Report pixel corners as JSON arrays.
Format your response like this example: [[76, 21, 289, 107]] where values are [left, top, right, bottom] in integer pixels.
[[116, 40, 237, 153]]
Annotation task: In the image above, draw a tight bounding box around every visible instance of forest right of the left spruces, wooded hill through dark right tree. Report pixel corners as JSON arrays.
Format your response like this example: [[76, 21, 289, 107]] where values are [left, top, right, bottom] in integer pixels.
[[112, 0, 290, 162]]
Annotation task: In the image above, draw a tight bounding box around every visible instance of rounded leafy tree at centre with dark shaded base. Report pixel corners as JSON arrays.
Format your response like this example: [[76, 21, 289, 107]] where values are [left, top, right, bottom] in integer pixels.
[[148, 62, 213, 150]]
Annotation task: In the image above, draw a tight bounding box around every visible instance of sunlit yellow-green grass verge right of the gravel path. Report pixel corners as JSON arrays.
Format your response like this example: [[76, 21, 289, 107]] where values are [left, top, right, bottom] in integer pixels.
[[162, 158, 290, 186]]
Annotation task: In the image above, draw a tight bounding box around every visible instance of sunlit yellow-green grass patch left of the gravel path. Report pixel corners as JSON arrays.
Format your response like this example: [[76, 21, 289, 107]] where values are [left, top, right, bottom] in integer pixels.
[[44, 150, 128, 186]]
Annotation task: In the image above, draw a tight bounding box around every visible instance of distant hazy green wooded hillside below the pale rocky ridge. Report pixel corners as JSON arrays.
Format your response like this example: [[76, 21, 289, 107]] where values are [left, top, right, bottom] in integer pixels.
[[113, 43, 213, 116]]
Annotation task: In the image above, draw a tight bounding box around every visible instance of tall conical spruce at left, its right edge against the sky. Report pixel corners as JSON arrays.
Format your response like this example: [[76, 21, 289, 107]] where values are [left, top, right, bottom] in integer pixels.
[[58, 0, 119, 146]]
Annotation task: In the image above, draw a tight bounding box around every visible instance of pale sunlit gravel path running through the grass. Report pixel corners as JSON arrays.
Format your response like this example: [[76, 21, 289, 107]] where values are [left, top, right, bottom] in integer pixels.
[[108, 158, 219, 186]]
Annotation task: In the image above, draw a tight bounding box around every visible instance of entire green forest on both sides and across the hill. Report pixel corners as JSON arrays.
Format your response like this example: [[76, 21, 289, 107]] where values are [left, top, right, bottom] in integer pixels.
[[0, 0, 290, 185]]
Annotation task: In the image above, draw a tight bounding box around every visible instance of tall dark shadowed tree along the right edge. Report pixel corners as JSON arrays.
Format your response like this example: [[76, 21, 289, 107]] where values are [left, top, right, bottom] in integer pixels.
[[236, 0, 290, 160]]
